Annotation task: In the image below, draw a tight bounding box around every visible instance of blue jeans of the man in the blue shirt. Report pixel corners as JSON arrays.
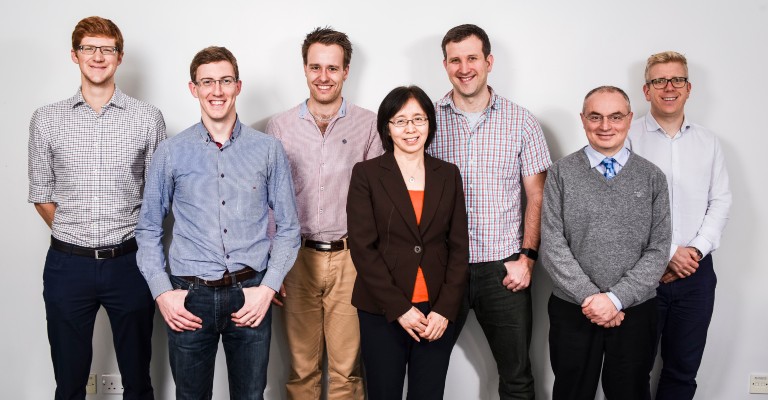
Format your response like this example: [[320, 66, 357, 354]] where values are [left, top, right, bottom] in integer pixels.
[[166, 270, 272, 400]]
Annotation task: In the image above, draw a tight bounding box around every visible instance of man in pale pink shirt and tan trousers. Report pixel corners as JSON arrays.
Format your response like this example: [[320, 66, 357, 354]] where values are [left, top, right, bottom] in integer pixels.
[[267, 28, 383, 400]]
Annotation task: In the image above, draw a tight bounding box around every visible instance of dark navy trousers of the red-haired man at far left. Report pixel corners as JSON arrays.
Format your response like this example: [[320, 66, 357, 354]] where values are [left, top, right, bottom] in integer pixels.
[[43, 249, 155, 400]]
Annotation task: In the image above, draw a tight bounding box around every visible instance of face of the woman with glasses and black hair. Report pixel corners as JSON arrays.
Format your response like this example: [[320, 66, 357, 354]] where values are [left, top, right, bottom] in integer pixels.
[[389, 98, 429, 155]]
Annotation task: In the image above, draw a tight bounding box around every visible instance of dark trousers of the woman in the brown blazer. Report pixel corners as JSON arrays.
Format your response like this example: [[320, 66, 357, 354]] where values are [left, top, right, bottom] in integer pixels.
[[357, 303, 455, 400]]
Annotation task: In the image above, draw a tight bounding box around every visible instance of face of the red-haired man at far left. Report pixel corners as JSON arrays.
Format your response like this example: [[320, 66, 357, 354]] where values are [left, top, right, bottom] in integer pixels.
[[71, 36, 123, 86]]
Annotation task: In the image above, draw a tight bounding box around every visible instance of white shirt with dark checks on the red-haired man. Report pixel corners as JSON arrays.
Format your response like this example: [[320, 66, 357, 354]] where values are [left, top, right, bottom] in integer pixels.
[[28, 87, 165, 247]]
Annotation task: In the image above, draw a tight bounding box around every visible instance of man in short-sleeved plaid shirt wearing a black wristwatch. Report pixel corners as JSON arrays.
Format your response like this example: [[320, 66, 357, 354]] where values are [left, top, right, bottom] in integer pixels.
[[428, 25, 552, 399]]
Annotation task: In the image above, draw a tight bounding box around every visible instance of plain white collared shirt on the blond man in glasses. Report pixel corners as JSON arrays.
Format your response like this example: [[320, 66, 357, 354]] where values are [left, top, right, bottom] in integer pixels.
[[629, 113, 731, 257]]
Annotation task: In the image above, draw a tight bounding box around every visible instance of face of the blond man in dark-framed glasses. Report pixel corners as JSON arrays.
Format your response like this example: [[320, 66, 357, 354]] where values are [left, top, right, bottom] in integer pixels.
[[643, 62, 691, 118]]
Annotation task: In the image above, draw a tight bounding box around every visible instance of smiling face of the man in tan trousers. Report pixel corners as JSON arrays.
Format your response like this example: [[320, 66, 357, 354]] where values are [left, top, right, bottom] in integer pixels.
[[304, 43, 349, 104]]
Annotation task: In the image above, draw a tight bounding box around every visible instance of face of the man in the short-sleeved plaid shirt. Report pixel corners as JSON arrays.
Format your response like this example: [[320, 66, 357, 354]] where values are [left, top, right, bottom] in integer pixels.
[[443, 35, 493, 98]]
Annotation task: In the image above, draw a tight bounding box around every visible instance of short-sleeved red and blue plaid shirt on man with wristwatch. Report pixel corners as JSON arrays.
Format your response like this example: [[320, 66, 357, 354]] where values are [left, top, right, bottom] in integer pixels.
[[427, 87, 552, 263]]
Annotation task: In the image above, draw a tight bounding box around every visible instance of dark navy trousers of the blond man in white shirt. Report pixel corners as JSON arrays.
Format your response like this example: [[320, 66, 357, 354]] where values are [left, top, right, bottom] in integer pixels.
[[656, 255, 717, 400]]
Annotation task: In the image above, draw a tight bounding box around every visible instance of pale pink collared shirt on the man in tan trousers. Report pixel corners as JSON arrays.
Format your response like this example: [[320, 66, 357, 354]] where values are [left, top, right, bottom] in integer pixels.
[[267, 100, 384, 241]]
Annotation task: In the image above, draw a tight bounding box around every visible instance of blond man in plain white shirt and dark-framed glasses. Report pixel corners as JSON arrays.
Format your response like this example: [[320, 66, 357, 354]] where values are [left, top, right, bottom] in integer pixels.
[[629, 51, 731, 400]]
